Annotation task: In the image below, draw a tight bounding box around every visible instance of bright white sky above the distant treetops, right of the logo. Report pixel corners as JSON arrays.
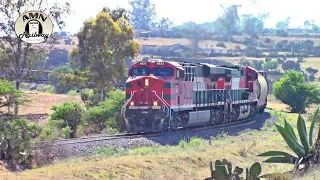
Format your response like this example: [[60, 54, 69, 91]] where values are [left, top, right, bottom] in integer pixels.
[[57, 0, 320, 33]]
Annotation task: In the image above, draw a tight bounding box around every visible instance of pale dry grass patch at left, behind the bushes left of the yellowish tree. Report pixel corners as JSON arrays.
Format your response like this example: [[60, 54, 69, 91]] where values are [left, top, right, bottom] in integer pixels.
[[19, 91, 81, 115]]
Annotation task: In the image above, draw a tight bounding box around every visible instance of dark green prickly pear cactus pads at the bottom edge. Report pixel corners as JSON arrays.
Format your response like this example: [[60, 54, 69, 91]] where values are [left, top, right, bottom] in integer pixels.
[[205, 159, 261, 180]]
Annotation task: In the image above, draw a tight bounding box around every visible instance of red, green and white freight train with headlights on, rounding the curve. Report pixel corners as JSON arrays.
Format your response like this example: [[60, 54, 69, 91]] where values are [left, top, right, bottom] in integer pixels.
[[122, 59, 268, 132]]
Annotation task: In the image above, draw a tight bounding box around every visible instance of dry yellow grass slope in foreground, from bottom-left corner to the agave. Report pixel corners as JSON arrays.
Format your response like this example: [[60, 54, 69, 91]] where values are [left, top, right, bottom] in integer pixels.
[[0, 132, 292, 180]]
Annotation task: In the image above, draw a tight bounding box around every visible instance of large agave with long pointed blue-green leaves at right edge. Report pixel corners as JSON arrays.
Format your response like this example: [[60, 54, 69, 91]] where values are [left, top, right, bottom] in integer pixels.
[[258, 108, 320, 170]]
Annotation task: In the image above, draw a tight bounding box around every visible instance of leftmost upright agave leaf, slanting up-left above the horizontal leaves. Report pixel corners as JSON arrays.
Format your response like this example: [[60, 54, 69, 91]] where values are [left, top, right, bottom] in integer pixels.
[[275, 124, 305, 157]]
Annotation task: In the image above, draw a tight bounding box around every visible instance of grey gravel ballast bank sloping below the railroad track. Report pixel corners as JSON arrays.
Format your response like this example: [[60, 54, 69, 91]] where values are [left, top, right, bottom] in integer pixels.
[[36, 112, 277, 164]]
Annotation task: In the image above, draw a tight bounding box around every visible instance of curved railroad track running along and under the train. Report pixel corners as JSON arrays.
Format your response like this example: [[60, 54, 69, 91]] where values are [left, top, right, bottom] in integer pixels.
[[34, 115, 259, 146]]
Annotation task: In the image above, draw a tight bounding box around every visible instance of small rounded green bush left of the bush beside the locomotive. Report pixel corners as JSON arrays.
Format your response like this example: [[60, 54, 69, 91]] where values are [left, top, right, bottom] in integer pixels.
[[50, 102, 84, 138]]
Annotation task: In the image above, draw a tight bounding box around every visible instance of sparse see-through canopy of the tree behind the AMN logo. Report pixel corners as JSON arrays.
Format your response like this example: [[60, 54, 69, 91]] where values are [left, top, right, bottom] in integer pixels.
[[0, 0, 70, 114]]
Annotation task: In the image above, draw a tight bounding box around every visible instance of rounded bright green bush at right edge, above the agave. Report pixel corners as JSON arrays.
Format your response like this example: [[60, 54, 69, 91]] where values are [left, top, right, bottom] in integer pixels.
[[272, 70, 320, 112]]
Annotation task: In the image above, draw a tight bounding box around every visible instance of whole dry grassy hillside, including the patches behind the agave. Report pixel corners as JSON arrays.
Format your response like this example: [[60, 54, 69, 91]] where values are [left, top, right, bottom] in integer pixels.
[[0, 97, 320, 180]]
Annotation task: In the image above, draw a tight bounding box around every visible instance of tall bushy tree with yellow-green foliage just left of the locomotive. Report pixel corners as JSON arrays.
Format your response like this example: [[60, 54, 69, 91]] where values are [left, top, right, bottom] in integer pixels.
[[62, 9, 139, 101]]
